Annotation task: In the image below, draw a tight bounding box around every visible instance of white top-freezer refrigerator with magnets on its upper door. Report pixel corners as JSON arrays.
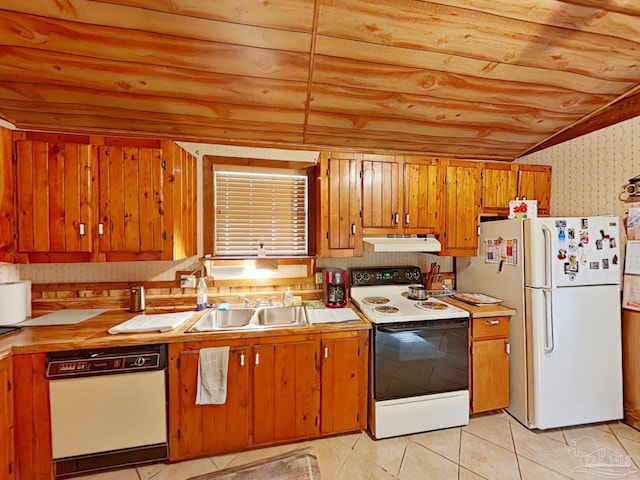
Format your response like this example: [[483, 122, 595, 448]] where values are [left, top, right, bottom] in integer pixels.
[[456, 216, 623, 429]]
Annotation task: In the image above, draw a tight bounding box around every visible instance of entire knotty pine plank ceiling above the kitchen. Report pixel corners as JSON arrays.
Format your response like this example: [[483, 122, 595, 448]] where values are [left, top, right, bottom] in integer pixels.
[[0, 0, 640, 161]]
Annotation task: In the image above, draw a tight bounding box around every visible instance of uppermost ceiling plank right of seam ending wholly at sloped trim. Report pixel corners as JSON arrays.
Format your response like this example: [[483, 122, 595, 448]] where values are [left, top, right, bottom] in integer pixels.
[[313, 56, 615, 114]]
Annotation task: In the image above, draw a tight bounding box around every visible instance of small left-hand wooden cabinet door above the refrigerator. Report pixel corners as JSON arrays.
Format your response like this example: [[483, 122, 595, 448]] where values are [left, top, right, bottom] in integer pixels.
[[482, 163, 518, 215]]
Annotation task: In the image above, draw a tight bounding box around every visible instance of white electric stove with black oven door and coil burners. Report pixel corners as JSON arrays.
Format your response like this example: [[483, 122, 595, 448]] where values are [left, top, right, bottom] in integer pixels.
[[350, 267, 469, 439]]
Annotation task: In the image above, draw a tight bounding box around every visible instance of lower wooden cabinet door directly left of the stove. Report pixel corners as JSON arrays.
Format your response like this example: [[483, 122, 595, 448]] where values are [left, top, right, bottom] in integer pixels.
[[320, 331, 369, 435]]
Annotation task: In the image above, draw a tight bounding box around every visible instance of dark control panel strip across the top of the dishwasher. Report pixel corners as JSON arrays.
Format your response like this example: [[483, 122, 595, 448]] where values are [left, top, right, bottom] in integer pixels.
[[46, 345, 167, 378]]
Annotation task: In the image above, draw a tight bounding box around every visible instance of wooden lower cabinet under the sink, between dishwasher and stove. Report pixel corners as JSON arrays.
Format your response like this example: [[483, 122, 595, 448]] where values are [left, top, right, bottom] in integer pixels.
[[169, 330, 369, 461]]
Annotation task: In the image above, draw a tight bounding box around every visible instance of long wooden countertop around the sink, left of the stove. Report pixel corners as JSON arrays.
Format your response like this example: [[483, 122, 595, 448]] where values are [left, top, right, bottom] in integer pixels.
[[0, 305, 371, 359]]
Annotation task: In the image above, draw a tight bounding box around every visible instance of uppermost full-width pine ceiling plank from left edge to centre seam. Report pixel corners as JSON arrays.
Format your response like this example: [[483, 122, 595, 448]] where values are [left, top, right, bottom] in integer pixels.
[[0, 12, 309, 81]]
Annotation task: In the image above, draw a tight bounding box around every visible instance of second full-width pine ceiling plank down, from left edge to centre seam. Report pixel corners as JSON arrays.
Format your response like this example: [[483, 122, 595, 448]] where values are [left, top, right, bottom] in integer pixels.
[[0, 46, 307, 108]]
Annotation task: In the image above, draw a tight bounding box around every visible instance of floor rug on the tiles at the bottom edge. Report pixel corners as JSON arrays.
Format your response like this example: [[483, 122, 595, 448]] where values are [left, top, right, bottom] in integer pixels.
[[188, 448, 320, 480]]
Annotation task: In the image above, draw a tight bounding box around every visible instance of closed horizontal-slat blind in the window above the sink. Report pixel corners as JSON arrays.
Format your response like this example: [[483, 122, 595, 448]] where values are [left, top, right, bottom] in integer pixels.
[[214, 171, 308, 256]]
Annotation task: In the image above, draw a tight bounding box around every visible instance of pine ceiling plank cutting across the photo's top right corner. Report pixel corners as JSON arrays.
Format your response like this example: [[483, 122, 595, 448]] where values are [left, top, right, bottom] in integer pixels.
[[432, 0, 640, 41]]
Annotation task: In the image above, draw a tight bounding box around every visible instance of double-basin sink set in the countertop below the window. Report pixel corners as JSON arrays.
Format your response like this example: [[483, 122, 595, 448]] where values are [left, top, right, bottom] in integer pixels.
[[187, 306, 308, 333]]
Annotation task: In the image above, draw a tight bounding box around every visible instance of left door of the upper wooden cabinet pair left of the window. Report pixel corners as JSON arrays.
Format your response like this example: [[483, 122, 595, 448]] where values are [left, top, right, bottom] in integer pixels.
[[14, 135, 95, 263]]
